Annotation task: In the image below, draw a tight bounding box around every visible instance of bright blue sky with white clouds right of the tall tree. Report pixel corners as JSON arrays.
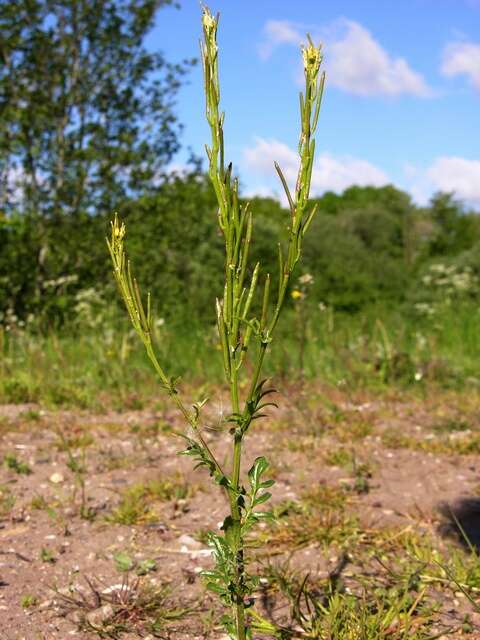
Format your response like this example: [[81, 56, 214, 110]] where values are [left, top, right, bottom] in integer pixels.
[[148, 0, 480, 207]]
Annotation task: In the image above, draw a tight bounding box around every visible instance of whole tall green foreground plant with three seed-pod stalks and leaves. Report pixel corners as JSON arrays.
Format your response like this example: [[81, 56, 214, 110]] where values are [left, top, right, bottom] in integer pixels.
[[108, 8, 325, 640]]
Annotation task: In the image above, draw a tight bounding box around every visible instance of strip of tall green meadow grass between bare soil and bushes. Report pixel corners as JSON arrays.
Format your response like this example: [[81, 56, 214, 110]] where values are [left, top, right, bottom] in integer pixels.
[[0, 306, 480, 410]]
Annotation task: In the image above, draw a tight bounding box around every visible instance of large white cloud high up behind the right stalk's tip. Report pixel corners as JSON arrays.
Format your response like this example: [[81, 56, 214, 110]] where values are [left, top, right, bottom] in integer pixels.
[[259, 20, 432, 97]]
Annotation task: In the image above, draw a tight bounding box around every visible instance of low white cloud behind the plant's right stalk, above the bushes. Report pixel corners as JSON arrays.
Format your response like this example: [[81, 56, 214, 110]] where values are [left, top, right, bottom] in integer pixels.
[[243, 138, 390, 201]]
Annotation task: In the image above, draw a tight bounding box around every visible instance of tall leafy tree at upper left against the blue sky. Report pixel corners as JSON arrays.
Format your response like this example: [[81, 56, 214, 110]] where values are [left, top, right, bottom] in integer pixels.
[[0, 0, 191, 217]]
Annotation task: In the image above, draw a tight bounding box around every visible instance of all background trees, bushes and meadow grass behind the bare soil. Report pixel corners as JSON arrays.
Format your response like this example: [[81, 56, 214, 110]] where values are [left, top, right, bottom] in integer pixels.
[[0, 0, 480, 405]]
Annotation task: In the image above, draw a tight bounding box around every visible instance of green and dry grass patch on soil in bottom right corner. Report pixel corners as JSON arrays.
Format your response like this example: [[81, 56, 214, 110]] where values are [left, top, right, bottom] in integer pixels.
[[251, 516, 480, 640]]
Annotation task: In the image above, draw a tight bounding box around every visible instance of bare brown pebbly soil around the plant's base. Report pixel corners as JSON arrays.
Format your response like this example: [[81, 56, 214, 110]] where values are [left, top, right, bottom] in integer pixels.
[[0, 385, 480, 640]]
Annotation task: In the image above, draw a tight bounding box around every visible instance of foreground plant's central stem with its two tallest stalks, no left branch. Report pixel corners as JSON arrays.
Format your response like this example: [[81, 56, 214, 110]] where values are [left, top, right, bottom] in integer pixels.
[[201, 12, 323, 640]]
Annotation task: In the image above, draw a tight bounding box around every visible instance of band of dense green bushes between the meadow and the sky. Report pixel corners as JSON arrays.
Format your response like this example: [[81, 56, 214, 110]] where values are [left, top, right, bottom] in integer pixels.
[[0, 175, 480, 331]]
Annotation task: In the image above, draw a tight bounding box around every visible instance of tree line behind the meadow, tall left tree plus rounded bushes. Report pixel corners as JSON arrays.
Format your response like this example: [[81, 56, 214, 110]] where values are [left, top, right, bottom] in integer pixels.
[[0, 0, 480, 327]]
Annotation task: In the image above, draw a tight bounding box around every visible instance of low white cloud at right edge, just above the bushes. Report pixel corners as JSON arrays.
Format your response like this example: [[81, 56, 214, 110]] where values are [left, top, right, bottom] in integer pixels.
[[427, 156, 480, 206]]
